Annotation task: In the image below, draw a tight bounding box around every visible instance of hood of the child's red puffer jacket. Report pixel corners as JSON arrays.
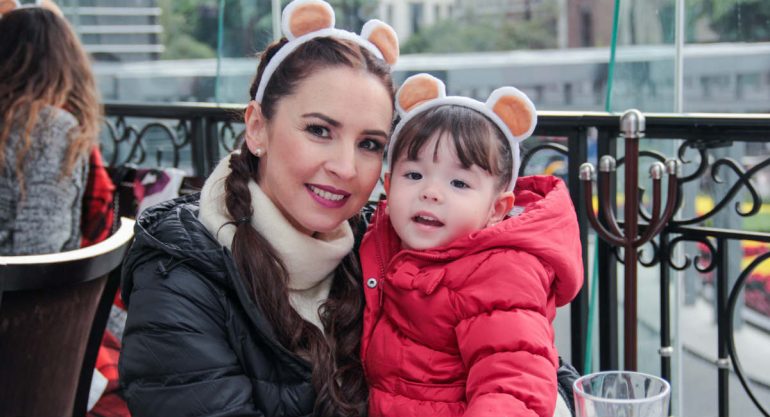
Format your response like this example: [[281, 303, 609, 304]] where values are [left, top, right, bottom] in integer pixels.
[[371, 176, 583, 306]]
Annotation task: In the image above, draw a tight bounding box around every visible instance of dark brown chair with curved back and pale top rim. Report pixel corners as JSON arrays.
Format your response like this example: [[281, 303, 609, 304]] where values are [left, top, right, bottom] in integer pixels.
[[0, 218, 134, 417]]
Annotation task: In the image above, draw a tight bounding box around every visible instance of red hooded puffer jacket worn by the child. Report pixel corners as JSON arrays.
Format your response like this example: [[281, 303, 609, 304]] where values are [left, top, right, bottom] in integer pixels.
[[360, 176, 583, 417]]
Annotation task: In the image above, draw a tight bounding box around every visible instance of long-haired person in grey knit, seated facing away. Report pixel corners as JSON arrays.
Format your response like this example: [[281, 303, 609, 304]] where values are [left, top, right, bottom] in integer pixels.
[[0, 1, 101, 256]]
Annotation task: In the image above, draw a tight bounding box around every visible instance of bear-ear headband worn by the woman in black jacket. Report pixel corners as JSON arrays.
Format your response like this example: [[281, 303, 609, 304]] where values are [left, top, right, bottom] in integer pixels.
[[254, 0, 399, 103]]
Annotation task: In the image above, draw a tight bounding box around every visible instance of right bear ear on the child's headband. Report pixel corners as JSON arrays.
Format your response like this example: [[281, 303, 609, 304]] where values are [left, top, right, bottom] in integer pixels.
[[486, 87, 537, 142]]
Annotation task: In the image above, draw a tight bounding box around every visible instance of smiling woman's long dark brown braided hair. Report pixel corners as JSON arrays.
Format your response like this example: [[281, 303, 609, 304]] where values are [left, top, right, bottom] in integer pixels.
[[225, 38, 393, 416]]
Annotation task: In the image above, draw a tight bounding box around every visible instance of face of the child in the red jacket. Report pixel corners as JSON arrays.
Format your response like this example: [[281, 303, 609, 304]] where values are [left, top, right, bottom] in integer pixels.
[[385, 134, 513, 250]]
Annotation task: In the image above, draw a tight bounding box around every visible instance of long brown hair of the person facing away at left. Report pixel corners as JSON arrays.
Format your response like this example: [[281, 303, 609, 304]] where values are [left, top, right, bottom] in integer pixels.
[[0, 7, 101, 190]]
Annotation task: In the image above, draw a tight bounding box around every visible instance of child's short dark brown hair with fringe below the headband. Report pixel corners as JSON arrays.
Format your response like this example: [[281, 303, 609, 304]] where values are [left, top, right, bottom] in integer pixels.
[[389, 105, 513, 190]]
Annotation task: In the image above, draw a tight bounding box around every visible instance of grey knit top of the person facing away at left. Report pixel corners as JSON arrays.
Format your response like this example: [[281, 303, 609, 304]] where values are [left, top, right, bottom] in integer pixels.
[[0, 107, 88, 256]]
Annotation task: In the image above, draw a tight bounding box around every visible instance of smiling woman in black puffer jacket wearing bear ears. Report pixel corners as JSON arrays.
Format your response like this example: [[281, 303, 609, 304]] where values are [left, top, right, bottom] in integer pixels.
[[120, 0, 397, 416]]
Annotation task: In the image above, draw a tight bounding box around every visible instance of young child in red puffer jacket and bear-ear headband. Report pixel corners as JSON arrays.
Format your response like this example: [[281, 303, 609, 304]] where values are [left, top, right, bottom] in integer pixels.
[[360, 74, 583, 417]]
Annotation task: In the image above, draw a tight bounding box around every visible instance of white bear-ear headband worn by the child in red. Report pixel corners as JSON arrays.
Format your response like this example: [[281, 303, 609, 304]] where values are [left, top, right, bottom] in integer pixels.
[[388, 74, 537, 191]]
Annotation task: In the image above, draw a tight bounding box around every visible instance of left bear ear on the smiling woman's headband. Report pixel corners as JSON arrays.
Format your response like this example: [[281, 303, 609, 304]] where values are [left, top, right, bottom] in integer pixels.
[[281, 0, 334, 40]]
